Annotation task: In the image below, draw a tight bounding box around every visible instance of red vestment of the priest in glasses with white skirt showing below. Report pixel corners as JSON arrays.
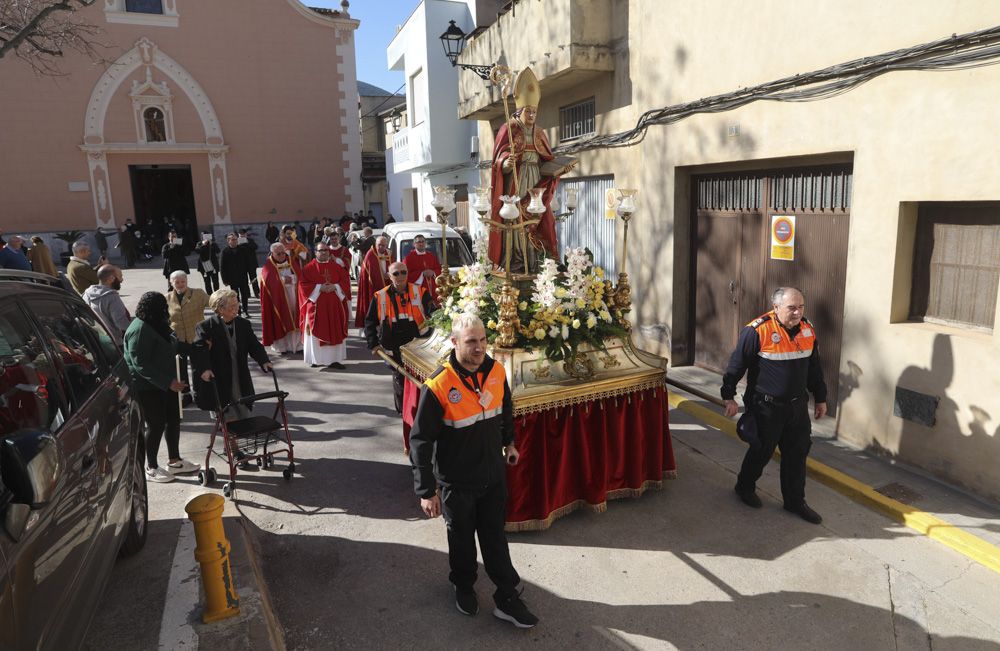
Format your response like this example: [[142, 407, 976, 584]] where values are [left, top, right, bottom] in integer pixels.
[[299, 260, 351, 346]]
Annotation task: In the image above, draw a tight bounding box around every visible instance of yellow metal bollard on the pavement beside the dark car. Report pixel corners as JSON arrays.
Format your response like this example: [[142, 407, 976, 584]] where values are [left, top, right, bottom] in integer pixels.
[[184, 493, 240, 624]]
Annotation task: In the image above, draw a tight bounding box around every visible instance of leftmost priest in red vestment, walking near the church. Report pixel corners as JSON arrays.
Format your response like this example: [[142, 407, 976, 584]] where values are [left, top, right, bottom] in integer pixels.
[[260, 242, 302, 353]]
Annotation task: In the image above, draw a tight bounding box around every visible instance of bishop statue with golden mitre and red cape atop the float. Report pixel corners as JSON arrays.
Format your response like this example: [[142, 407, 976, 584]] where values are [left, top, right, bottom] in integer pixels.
[[489, 68, 576, 273]]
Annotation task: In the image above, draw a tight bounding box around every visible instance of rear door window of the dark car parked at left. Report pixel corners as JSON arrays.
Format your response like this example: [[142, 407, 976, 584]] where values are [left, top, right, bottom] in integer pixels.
[[31, 300, 108, 407]]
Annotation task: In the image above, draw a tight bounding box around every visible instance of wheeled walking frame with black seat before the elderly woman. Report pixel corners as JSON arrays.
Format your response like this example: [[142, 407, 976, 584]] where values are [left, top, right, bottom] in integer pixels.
[[198, 369, 295, 498]]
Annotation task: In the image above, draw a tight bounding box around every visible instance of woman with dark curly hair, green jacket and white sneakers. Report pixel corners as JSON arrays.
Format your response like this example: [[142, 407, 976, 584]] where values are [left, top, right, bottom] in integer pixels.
[[124, 292, 200, 483]]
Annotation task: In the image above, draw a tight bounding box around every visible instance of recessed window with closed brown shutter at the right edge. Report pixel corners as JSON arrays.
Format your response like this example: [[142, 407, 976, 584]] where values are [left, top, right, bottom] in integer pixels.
[[910, 202, 1000, 330]]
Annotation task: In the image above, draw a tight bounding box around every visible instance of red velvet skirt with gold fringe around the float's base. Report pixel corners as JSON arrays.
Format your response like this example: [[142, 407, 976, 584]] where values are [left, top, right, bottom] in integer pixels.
[[403, 380, 677, 531]]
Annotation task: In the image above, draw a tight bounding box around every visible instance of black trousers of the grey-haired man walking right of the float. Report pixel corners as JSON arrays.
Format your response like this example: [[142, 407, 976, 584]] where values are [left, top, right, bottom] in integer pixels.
[[736, 394, 812, 507]]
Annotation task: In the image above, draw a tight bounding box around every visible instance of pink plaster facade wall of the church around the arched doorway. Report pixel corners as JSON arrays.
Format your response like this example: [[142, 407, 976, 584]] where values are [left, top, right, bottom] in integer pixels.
[[0, 0, 362, 233]]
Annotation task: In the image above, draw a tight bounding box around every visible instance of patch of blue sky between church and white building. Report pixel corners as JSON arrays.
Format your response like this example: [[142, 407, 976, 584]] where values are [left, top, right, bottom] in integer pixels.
[[303, 0, 416, 93]]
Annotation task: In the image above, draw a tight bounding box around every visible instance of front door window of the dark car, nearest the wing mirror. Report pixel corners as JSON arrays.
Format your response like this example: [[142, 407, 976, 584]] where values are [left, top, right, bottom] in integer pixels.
[[0, 302, 66, 438]]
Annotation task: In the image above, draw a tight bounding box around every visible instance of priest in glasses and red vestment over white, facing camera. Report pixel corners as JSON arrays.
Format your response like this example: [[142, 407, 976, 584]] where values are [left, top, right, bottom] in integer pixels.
[[299, 242, 351, 369]]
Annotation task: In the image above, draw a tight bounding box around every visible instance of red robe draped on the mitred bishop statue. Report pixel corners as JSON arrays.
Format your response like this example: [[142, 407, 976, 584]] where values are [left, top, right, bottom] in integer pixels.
[[489, 120, 559, 266]]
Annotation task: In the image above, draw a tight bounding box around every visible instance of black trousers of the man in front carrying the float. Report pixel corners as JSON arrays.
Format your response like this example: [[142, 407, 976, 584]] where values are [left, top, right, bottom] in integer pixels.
[[441, 481, 521, 603]]
